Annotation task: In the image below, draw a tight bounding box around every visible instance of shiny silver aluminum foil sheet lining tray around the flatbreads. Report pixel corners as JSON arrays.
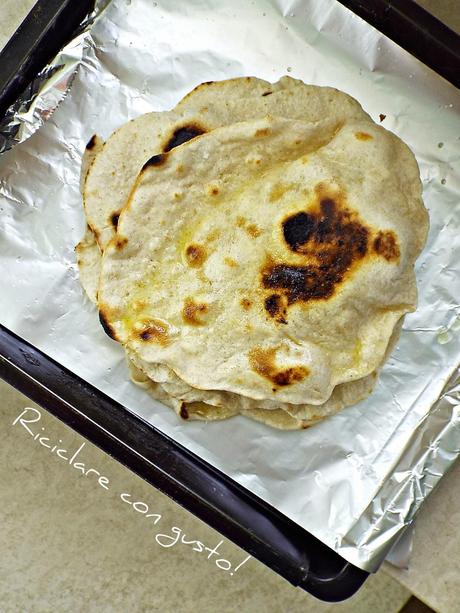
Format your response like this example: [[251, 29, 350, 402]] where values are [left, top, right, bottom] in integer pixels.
[[0, 0, 460, 571]]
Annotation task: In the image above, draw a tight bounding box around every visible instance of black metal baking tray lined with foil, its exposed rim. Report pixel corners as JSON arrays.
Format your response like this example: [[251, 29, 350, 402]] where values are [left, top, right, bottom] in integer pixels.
[[0, 0, 460, 601]]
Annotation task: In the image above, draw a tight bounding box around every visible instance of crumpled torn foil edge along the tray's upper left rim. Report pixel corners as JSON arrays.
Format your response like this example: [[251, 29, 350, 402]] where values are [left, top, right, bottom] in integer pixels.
[[0, 0, 111, 155]]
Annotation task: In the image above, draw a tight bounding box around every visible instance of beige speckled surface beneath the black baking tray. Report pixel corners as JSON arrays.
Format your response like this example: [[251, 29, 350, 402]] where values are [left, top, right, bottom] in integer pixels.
[[0, 0, 460, 613]]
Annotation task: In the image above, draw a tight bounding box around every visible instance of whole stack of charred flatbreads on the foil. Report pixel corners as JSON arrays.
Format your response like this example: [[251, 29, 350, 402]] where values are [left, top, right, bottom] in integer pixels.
[[76, 77, 428, 429]]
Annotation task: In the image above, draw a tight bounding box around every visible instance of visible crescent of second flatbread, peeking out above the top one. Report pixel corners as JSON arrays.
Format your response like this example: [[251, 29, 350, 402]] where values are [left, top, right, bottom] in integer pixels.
[[84, 77, 368, 250]]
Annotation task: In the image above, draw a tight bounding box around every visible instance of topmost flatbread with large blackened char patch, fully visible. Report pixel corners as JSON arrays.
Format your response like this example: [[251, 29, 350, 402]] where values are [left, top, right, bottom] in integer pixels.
[[99, 114, 427, 405]]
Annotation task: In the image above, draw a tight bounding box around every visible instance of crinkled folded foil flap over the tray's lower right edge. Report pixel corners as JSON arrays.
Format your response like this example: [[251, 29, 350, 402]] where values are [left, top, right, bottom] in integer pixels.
[[335, 364, 460, 572]]
